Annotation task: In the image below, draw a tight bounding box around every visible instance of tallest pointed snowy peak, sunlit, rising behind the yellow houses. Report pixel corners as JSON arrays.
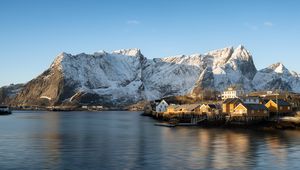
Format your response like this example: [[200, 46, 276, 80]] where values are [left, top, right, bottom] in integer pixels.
[[203, 45, 257, 90]]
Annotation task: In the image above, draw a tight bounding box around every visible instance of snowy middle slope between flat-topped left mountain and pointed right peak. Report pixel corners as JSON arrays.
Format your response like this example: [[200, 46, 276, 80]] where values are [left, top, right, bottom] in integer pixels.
[[142, 54, 202, 100]]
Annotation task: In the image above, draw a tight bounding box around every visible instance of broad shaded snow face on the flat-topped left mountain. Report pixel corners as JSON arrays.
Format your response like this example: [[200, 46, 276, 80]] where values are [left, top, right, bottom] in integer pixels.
[[51, 49, 143, 104]]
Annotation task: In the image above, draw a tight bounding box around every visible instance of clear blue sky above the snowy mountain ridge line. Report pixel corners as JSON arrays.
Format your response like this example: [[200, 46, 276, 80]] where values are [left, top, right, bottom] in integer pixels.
[[0, 0, 300, 86]]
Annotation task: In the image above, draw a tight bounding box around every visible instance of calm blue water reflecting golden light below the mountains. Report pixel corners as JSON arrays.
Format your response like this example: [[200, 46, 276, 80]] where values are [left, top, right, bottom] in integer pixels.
[[0, 111, 300, 170]]
